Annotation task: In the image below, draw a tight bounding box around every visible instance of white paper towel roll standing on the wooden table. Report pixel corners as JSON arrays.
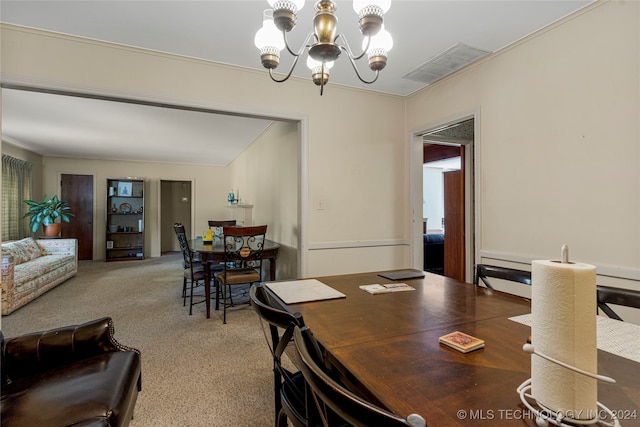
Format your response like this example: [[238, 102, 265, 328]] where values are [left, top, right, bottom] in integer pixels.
[[531, 260, 598, 420]]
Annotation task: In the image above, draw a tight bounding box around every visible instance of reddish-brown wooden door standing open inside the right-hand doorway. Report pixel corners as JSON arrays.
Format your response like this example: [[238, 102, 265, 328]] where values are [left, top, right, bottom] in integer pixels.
[[442, 170, 465, 282]]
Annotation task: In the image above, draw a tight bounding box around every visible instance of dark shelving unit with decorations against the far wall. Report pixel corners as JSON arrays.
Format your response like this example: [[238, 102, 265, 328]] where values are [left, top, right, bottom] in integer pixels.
[[106, 178, 144, 262]]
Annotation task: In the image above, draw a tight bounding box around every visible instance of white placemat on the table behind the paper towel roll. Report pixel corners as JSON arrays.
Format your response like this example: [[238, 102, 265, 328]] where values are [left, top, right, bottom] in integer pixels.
[[509, 314, 640, 363]]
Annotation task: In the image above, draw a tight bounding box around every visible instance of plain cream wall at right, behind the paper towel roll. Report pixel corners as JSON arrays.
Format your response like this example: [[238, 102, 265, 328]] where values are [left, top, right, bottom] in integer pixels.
[[407, 1, 640, 320]]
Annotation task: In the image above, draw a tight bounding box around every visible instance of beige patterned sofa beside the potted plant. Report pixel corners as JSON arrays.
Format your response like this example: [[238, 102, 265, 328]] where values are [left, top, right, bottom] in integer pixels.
[[2, 237, 78, 315]]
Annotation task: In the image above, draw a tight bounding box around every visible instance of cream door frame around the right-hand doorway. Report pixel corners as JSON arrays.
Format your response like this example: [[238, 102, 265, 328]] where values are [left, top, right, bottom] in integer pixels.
[[409, 109, 480, 282]]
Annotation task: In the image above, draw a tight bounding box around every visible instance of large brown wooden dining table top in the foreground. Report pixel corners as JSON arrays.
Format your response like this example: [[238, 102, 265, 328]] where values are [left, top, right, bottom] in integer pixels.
[[267, 272, 640, 427]]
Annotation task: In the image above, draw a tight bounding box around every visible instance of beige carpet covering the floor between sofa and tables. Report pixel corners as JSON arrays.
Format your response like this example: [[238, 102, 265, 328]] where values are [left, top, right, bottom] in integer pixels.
[[2, 253, 274, 427]]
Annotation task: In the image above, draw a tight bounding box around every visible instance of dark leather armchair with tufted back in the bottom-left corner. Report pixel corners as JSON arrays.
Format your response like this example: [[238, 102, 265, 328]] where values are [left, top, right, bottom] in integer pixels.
[[0, 317, 142, 427]]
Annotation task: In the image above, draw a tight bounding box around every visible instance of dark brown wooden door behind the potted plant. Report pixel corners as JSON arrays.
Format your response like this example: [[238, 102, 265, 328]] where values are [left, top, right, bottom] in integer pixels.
[[60, 174, 93, 260]]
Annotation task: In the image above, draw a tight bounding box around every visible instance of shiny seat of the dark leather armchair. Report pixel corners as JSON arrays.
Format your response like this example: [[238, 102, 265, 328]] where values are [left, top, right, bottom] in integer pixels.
[[0, 351, 140, 426]]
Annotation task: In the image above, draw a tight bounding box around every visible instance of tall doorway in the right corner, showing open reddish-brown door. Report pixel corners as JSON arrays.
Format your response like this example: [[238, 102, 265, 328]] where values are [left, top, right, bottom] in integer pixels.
[[412, 116, 475, 281]]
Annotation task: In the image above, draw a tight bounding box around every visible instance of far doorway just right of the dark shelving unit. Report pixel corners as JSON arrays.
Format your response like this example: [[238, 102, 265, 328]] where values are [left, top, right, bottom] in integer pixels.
[[160, 180, 192, 253]]
